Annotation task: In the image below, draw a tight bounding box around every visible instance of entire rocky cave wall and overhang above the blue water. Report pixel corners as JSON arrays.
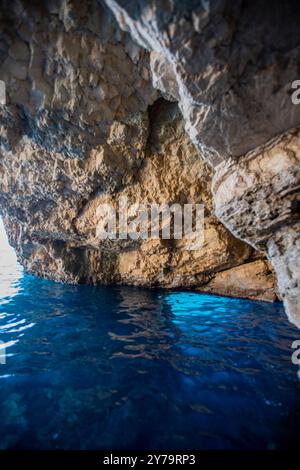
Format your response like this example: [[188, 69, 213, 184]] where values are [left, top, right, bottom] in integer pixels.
[[0, 0, 300, 316]]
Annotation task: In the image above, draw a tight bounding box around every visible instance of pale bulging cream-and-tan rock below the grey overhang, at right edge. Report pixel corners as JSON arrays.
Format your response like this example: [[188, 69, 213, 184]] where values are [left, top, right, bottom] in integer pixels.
[[213, 130, 300, 323]]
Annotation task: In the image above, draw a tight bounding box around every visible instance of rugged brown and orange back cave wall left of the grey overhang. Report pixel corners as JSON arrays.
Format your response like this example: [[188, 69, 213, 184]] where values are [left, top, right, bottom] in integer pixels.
[[0, 0, 275, 300]]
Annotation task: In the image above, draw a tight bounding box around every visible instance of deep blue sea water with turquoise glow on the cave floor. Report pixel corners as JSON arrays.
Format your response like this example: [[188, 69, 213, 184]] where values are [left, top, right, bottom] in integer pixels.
[[0, 218, 300, 450]]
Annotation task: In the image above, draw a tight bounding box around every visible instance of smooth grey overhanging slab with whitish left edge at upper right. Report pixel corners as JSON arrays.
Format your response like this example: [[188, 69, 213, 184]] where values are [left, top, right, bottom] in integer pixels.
[[106, 0, 300, 166]]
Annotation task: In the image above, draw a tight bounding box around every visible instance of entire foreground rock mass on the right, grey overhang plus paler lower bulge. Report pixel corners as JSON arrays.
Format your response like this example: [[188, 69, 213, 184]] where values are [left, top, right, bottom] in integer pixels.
[[106, 0, 300, 327]]
